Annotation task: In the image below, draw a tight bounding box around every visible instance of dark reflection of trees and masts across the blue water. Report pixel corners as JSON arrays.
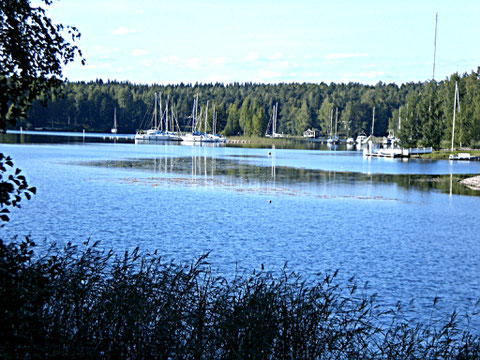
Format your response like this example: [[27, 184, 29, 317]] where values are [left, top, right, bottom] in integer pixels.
[[84, 155, 480, 196]]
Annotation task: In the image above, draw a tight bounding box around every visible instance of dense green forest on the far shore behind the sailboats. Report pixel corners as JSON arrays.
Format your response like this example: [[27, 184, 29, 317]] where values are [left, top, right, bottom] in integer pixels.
[[19, 67, 480, 148]]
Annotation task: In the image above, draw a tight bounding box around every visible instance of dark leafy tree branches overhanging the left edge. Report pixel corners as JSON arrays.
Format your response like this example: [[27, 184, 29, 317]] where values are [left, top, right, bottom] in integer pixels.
[[0, 0, 83, 222]]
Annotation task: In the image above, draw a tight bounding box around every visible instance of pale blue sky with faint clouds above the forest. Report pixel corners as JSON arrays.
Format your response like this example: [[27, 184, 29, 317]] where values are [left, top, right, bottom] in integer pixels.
[[43, 0, 480, 84]]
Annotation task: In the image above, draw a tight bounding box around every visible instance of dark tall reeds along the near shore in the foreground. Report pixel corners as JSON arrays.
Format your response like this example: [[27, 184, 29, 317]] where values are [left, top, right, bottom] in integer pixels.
[[0, 238, 480, 359]]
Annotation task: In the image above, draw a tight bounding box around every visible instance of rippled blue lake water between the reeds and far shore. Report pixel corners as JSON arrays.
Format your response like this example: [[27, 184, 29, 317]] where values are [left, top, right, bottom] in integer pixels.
[[0, 135, 480, 331]]
